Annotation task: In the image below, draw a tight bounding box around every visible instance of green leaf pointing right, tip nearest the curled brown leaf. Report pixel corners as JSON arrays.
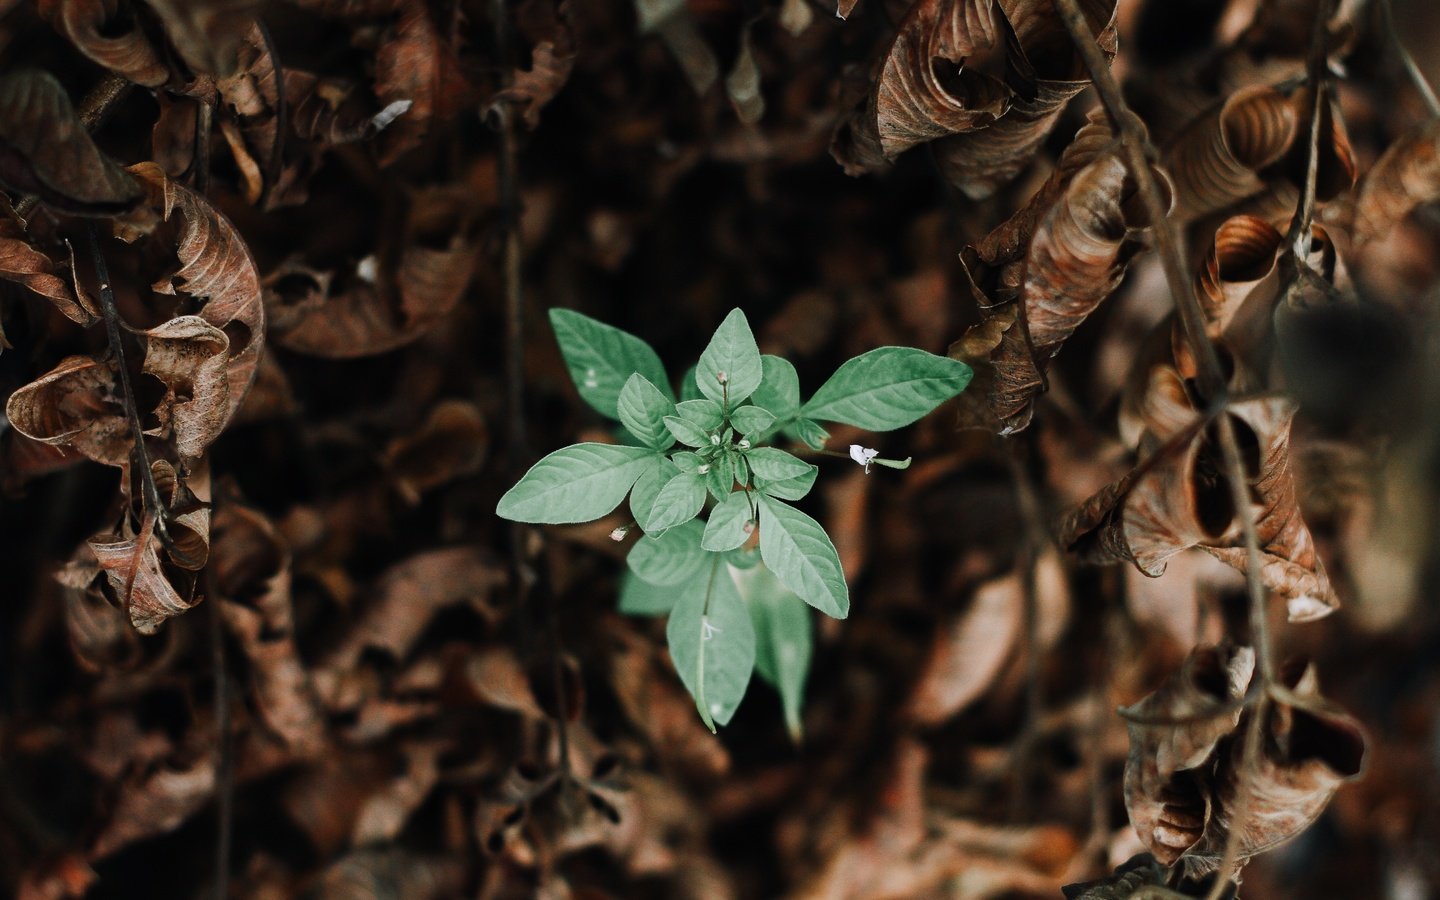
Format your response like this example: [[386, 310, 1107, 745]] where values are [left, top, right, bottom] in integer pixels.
[[802, 347, 973, 431]]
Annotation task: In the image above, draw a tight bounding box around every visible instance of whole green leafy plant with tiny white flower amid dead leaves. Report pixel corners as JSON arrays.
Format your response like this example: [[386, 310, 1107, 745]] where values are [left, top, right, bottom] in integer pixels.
[[495, 310, 971, 737]]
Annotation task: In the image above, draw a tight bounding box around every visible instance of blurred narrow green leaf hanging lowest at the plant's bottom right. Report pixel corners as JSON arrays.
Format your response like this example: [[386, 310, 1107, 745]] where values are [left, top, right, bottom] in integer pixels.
[[734, 566, 814, 743]]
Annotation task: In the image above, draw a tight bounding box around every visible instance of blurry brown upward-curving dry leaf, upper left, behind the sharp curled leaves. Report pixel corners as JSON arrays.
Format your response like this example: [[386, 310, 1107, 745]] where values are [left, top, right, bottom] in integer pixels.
[[268, 192, 477, 359]]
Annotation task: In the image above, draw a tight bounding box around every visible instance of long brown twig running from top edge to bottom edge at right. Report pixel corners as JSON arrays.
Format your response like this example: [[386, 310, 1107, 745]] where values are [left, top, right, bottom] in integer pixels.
[[1056, 0, 1274, 900]]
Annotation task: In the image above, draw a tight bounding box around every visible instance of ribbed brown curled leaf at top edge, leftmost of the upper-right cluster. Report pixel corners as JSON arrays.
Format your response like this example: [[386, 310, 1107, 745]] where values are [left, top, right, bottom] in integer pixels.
[[831, 0, 1011, 174]]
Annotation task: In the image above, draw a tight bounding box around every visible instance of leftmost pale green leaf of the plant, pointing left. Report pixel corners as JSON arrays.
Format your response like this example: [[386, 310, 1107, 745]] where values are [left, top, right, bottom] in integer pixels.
[[495, 444, 655, 526]]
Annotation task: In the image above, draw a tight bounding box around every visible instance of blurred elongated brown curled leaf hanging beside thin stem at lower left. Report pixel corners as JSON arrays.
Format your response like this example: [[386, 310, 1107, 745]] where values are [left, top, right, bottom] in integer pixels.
[[212, 504, 324, 757]]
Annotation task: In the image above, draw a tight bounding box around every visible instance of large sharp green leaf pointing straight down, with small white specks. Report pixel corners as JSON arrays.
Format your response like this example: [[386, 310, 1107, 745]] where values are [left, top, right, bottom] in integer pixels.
[[665, 556, 755, 732]]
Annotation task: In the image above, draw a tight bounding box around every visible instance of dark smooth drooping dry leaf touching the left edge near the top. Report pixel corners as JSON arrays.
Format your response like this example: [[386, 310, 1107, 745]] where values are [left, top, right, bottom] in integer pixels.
[[0, 69, 144, 216]]
